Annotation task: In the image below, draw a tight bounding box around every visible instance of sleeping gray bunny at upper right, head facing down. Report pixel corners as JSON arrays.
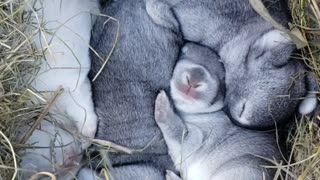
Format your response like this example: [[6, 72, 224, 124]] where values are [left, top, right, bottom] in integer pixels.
[[146, 0, 318, 129]]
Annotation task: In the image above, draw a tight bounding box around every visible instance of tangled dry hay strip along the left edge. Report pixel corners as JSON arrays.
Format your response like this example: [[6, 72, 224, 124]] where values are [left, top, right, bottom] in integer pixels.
[[0, 0, 43, 179]]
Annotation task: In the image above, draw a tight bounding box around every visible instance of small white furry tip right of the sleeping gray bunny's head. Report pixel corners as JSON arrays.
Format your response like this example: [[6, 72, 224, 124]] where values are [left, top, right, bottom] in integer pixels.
[[299, 92, 318, 115]]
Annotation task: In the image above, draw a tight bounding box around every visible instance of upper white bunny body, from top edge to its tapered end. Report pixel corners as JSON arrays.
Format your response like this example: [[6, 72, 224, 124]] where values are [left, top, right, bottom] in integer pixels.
[[28, 0, 98, 137]]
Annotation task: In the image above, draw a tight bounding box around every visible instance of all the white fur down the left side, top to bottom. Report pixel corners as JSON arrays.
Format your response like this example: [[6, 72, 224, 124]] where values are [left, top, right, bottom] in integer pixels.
[[21, 0, 98, 177]]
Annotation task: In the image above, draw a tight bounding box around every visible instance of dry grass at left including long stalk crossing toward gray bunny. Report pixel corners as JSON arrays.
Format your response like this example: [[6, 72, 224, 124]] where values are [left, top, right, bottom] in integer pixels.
[[0, 0, 125, 180]]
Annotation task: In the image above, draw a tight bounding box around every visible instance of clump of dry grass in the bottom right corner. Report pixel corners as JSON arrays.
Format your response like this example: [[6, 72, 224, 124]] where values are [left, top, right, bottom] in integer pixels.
[[286, 117, 320, 180]]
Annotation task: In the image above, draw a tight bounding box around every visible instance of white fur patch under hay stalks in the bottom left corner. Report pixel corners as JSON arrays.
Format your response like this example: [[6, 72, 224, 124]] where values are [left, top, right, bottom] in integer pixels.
[[19, 121, 82, 179]]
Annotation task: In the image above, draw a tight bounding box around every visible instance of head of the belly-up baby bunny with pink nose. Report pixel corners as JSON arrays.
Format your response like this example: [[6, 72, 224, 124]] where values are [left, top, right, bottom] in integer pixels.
[[170, 43, 224, 113]]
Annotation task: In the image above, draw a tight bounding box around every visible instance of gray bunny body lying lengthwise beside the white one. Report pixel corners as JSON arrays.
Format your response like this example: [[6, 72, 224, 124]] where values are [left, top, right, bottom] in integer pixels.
[[89, 0, 182, 180]]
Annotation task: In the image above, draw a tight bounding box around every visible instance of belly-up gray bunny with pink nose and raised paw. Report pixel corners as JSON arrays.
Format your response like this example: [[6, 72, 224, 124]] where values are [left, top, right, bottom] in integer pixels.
[[155, 45, 280, 180]]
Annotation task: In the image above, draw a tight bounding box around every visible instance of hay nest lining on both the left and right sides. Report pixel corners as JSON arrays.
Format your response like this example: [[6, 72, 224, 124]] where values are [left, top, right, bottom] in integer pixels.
[[0, 0, 320, 180]]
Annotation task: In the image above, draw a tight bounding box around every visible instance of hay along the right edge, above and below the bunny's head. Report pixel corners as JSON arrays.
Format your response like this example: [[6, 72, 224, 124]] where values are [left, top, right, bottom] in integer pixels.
[[281, 0, 320, 180]]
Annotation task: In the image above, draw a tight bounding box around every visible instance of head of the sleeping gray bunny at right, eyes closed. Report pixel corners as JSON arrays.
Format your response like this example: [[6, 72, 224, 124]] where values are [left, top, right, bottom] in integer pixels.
[[224, 30, 316, 129]]
